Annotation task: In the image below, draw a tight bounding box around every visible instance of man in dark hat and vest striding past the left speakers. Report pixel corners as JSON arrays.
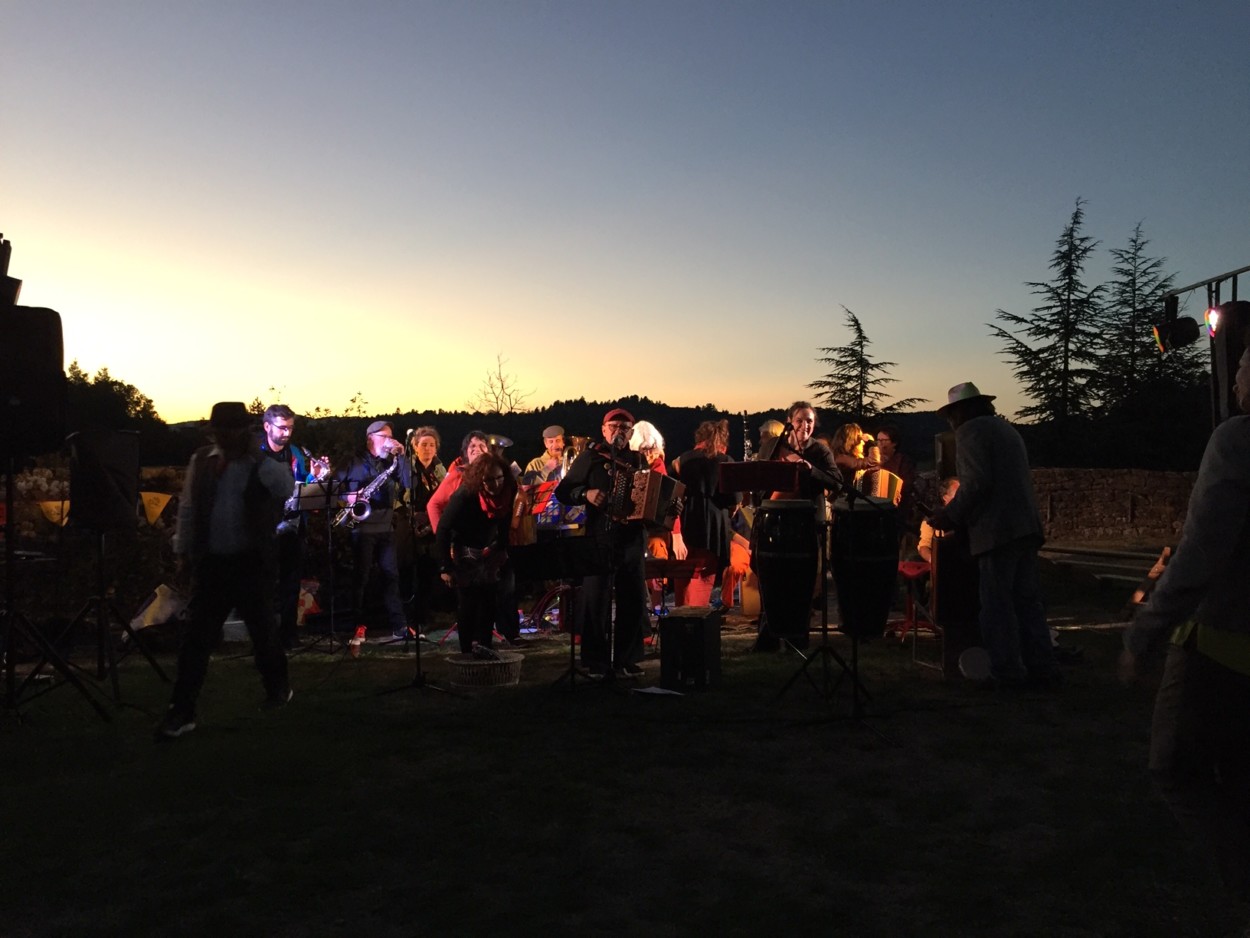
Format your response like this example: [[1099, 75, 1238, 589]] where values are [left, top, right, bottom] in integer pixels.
[[156, 401, 294, 739]]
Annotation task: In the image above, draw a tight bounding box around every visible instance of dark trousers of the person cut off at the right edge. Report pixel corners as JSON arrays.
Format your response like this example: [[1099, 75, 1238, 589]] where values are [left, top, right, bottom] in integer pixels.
[[1150, 645, 1250, 902]]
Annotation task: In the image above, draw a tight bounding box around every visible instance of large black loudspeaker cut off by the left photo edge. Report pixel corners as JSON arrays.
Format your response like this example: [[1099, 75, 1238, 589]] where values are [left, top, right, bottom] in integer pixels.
[[0, 306, 65, 456]]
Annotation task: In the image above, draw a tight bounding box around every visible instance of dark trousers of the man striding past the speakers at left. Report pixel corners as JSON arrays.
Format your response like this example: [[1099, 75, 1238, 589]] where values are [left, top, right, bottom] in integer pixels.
[[171, 552, 289, 714]]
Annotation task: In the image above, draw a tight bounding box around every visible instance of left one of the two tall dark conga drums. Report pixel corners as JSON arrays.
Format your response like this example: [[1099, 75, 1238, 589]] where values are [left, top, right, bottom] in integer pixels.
[[751, 499, 819, 650]]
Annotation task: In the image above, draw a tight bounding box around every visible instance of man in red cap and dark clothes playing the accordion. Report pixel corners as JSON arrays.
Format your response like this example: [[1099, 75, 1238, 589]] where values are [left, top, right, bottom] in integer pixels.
[[555, 408, 648, 679]]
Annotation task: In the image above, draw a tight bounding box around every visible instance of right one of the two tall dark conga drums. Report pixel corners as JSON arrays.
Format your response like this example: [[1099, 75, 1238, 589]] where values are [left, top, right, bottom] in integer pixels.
[[830, 497, 899, 638]]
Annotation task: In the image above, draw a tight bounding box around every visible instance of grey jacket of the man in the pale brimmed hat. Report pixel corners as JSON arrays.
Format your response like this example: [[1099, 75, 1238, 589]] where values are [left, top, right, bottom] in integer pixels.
[[943, 415, 1044, 557]]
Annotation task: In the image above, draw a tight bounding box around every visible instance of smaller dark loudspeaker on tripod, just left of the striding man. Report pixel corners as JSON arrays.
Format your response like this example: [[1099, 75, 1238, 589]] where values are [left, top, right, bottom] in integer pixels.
[[69, 430, 139, 532]]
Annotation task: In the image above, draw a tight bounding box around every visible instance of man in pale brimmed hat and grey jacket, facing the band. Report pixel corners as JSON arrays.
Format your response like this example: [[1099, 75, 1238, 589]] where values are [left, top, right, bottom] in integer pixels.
[[930, 381, 1059, 687]]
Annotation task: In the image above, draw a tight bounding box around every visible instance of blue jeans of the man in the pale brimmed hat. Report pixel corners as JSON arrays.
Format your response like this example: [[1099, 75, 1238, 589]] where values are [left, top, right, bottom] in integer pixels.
[[976, 538, 1058, 682]]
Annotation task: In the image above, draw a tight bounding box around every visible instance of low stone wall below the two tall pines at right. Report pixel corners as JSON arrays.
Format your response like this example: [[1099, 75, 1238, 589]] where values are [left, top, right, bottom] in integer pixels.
[[1033, 469, 1198, 547]]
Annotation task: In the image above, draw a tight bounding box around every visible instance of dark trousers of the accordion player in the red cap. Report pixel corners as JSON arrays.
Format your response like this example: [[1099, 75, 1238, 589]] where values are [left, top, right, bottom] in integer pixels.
[[576, 530, 648, 668]]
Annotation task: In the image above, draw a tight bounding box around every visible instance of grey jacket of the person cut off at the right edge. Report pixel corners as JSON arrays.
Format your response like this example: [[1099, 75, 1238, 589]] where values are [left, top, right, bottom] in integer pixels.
[[1124, 416, 1250, 654]]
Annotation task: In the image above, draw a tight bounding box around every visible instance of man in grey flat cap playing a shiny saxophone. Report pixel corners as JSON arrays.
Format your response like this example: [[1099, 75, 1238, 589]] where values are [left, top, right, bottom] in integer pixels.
[[339, 420, 413, 639]]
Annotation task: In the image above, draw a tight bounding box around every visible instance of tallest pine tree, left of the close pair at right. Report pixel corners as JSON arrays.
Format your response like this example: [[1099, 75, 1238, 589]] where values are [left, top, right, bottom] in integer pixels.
[[990, 199, 1103, 424]]
